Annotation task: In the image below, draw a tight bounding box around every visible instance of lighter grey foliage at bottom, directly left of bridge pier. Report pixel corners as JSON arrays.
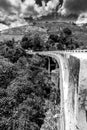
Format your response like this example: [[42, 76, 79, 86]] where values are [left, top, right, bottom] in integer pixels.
[[41, 101, 60, 130]]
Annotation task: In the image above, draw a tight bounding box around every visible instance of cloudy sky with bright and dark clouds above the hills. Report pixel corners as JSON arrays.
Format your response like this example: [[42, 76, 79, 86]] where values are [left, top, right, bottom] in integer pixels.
[[0, 0, 87, 25]]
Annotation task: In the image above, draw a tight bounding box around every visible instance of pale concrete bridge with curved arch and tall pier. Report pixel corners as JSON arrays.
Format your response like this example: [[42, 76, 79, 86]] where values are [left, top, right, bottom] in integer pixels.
[[26, 50, 87, 130]]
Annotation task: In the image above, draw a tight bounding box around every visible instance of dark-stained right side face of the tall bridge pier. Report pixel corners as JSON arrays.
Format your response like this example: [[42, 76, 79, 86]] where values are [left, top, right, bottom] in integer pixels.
[[68, 56, 80, 130]]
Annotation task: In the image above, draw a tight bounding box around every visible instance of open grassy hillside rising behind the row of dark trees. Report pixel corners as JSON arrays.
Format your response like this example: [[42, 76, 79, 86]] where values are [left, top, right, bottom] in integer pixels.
[[0, 21, 87, 46]]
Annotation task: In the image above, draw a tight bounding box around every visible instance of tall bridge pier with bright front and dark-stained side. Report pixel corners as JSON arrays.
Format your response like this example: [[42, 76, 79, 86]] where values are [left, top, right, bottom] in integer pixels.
[[61, 56, 80, 130]]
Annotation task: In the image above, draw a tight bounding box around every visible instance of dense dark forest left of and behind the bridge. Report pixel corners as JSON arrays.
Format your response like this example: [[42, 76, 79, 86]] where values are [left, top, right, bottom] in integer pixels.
[[0, 28, 83, 130]]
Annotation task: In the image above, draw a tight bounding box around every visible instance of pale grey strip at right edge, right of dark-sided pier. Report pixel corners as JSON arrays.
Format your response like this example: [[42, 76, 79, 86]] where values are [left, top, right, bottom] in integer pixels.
[[78, 59, 87, 130]]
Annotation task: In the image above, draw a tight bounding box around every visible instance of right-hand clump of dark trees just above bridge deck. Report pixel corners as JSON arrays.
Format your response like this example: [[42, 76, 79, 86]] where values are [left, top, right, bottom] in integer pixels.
[[46, 28, 82, 51]]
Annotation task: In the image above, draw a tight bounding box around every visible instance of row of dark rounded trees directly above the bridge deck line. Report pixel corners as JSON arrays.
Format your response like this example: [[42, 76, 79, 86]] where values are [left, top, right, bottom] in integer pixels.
[[21, 28, 84, 51]]
